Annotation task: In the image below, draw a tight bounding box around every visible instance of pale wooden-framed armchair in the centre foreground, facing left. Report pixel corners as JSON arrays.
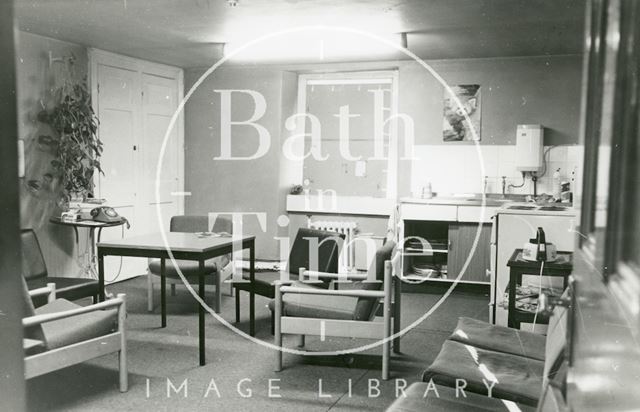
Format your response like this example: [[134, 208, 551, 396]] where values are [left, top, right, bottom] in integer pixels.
[[270, 240, 401, 380]]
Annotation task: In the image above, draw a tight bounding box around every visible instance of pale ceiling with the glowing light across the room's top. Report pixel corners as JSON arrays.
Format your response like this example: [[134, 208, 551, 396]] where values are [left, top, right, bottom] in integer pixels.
[[16, 0, 584, 68]]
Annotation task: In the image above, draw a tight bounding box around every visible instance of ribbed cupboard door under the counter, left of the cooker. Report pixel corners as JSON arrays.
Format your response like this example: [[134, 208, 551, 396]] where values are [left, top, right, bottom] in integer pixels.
[[447, 223, 491, 283]]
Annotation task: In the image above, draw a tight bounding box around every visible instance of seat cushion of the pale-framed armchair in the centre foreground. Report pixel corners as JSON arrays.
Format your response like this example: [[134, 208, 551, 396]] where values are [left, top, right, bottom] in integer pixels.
[[269, 282, 358, 320]]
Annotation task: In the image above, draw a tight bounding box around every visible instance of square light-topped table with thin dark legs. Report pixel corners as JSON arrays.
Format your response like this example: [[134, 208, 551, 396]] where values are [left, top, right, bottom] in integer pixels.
[[98, 232, 255, 365]]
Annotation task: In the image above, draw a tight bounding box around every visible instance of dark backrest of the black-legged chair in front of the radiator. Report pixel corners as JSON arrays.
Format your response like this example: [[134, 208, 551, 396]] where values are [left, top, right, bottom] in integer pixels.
[[288, 228, 344, 275]]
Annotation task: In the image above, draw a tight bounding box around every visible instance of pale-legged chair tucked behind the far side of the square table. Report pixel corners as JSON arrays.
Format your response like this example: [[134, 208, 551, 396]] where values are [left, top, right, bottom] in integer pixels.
[[147, 215, 233, 313]]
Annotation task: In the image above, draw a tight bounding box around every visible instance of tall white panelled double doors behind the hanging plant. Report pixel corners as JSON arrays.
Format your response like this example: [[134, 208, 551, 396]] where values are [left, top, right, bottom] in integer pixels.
[[89, 49, 184, 282]]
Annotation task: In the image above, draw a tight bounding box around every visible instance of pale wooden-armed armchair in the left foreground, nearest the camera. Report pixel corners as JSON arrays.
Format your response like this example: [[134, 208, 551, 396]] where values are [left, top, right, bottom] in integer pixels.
[[22, 279, 128, 392]]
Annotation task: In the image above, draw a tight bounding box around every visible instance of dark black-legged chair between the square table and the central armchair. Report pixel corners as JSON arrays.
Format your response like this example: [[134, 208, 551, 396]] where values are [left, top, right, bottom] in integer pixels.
[[233, 228, 344, 336]]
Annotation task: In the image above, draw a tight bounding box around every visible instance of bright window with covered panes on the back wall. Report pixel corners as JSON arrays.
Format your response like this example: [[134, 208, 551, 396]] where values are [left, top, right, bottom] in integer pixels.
[[298, 71, 397, 198]]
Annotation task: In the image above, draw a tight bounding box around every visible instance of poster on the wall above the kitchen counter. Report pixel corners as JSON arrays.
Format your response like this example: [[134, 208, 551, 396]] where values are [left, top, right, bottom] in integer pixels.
[[442, 84, 482, 142]]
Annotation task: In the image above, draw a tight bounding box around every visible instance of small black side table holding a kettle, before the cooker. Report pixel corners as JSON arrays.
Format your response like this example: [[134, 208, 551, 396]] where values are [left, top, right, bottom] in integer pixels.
[[507, 249, 573, 329]]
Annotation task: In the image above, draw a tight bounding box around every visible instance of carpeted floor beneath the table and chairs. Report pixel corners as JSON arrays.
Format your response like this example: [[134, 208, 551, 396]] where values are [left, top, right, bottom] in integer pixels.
[[23, 277, 488, 412]]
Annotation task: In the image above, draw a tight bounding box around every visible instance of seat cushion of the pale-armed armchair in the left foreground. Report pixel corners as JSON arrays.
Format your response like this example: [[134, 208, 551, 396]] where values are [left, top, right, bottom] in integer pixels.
[[36, 299, 118, 350]]
